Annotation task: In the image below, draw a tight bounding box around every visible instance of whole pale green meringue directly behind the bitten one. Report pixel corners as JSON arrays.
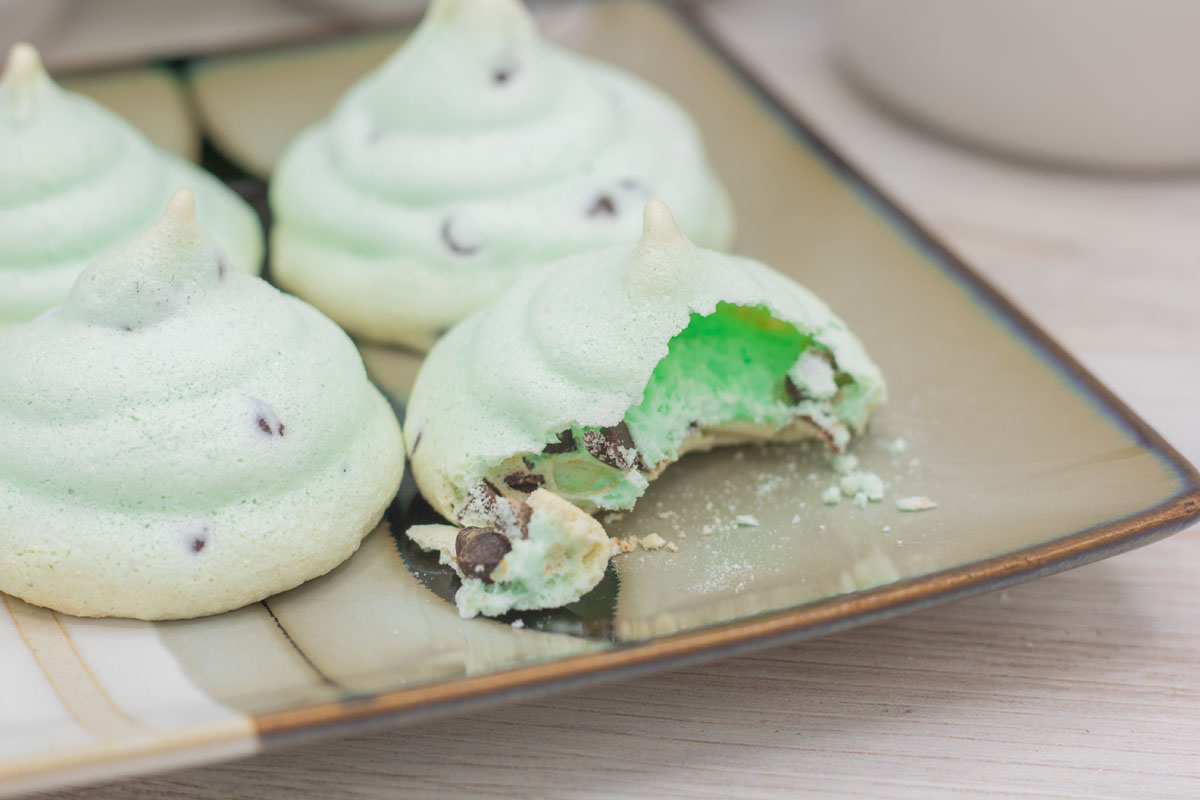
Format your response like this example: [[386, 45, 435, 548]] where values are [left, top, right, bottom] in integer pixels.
[[271, 0, 733, 349]]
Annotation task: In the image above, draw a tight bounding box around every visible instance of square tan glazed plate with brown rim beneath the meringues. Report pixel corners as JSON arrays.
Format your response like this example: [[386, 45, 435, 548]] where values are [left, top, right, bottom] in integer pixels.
[[0, 1, 1200, 792]]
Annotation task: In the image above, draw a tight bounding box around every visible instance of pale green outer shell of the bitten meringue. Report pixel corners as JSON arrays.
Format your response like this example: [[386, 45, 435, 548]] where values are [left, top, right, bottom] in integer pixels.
[[404, 200, 886, 525]]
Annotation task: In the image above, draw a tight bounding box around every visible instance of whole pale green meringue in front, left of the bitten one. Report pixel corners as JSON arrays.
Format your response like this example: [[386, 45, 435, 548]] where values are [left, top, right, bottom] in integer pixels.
[[0, 191, 404, 619]]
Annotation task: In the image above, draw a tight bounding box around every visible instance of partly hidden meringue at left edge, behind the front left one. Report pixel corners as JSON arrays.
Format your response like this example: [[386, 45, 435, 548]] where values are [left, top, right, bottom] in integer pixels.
[[0, 43, 263, 335]]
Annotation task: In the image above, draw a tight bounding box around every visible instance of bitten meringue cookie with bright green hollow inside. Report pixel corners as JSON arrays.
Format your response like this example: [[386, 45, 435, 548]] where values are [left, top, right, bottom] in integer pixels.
[[404, 200, 886, 613]]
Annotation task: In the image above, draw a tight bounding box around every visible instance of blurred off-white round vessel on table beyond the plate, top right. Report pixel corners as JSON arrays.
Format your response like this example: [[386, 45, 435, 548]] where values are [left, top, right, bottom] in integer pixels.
[[826, 0, 1200, 172]]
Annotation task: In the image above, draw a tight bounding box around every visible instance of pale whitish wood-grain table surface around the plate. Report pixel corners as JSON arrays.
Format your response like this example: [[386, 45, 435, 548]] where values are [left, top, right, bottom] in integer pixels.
[[42, 0, 1200, 800]]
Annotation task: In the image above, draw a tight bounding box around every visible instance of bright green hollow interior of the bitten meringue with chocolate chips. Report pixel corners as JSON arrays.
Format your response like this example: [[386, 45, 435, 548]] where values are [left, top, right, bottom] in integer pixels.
[[490, 303, 852, 512]]
